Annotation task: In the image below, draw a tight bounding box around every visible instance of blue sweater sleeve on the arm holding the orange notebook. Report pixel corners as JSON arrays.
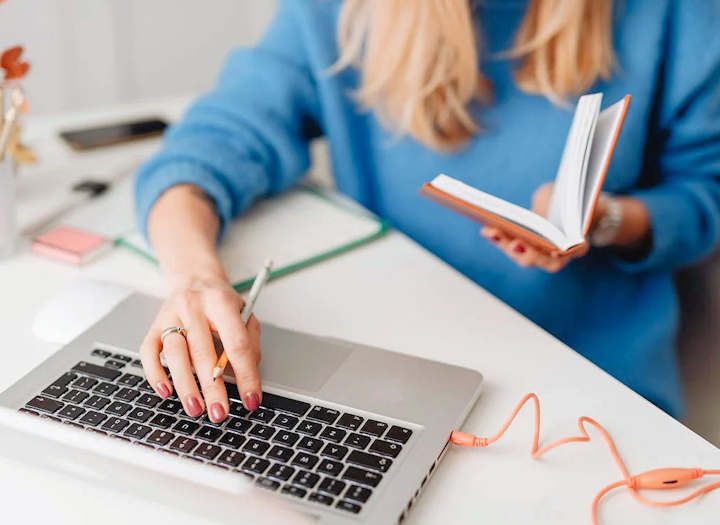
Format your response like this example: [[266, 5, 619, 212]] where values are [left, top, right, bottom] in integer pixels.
[[615, 0, 720, 272]]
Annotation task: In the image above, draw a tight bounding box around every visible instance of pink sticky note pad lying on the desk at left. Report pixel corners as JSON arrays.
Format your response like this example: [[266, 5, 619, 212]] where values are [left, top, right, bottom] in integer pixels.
[[32, 226, 112, 265]]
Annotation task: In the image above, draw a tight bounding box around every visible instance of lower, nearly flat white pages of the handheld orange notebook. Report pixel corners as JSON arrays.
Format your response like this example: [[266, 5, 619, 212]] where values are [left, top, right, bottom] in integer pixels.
[[430, 175, 575, 250]]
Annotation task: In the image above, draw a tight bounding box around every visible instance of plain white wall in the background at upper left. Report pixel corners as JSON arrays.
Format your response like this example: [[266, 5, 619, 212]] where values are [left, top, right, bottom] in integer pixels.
[[0, 0, 275, 114]]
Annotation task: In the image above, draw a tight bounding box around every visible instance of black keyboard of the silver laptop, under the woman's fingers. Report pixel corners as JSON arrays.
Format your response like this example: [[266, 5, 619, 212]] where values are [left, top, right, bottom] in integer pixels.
[[20, 349, 413, 514]]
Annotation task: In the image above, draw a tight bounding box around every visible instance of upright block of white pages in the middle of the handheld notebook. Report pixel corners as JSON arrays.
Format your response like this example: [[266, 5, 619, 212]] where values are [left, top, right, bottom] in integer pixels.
[[548, 93, 602, 242]]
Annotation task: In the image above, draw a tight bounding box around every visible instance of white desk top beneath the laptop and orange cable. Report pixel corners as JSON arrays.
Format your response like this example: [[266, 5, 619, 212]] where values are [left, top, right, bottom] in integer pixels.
[[0, 101, 720, 524]]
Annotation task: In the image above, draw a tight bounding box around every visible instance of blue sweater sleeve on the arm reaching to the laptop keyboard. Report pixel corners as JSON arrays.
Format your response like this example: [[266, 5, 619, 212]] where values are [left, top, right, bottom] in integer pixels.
[[135, 1, 320, 237]]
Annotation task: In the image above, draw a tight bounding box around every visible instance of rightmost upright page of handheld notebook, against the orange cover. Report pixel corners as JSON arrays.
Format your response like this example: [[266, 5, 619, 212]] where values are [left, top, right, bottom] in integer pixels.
[[582, 99, 627, 231]]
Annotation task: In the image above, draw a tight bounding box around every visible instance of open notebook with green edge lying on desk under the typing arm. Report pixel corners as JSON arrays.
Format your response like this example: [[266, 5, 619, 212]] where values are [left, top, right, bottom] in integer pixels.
[[116, 187, 387, 291]]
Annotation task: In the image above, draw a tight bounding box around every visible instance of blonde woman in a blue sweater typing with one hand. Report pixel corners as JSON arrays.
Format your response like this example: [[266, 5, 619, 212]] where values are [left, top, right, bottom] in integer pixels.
[[136, 0, 720, 421]]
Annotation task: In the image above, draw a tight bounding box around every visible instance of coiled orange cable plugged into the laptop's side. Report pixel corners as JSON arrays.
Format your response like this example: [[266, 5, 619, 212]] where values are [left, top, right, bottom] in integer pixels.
[[450, 393, 720, 525]]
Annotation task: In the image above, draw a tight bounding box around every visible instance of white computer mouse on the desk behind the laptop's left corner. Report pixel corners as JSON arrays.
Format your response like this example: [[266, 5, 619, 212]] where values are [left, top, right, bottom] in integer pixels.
[[32, 280, 133, 344]]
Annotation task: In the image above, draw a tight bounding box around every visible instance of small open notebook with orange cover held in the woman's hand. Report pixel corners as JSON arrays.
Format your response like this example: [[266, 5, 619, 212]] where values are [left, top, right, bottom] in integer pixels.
[[421, 93, 630, 253]]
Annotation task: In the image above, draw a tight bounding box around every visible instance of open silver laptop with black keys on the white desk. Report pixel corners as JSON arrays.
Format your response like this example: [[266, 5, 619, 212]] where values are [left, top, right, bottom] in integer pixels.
[[0, 294, 482, 523]]
